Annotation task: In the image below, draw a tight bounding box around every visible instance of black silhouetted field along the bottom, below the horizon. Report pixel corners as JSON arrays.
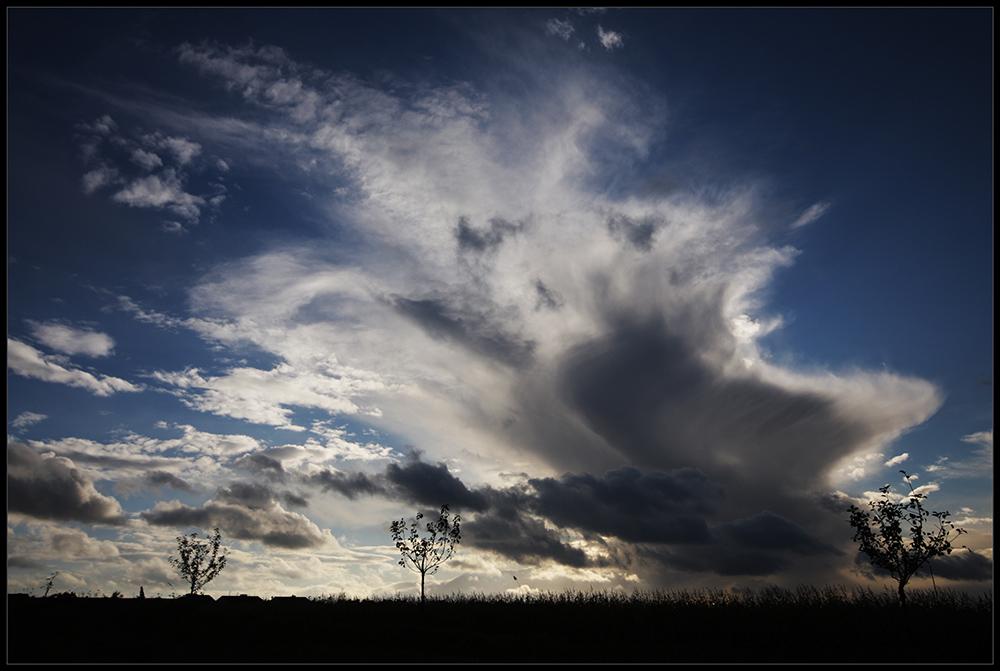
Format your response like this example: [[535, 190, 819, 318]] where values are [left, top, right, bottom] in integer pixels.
[[7, 591, 993, 663]]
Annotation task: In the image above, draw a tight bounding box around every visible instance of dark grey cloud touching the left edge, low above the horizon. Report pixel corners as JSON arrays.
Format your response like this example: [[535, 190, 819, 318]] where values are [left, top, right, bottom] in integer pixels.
[[7, 443, 128, 526]]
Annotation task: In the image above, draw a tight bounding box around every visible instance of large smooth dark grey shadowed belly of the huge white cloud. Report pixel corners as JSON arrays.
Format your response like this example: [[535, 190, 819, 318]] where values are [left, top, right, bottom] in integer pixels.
[[560, 316, 871, 512]]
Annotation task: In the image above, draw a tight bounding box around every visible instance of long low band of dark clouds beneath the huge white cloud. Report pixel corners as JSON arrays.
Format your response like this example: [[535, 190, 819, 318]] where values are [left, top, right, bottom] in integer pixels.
[[308, 454, 839, 575]]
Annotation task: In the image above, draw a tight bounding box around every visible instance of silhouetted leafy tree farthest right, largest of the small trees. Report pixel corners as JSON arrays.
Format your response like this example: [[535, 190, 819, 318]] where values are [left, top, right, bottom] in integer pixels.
[[848, 471, 965, 606]]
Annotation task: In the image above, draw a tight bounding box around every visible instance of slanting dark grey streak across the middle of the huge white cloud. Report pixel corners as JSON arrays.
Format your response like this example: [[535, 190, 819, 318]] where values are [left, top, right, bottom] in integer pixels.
[[392, 296, 535, 368]]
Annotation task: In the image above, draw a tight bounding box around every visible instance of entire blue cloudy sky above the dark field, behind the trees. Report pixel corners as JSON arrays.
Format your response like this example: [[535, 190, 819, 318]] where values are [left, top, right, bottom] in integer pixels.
[[7, 8, 993, 597]]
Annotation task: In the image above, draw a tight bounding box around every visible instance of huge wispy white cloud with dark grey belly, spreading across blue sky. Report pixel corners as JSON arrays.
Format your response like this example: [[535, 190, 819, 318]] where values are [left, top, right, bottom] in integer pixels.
[[150, 38, 941, 504]]
